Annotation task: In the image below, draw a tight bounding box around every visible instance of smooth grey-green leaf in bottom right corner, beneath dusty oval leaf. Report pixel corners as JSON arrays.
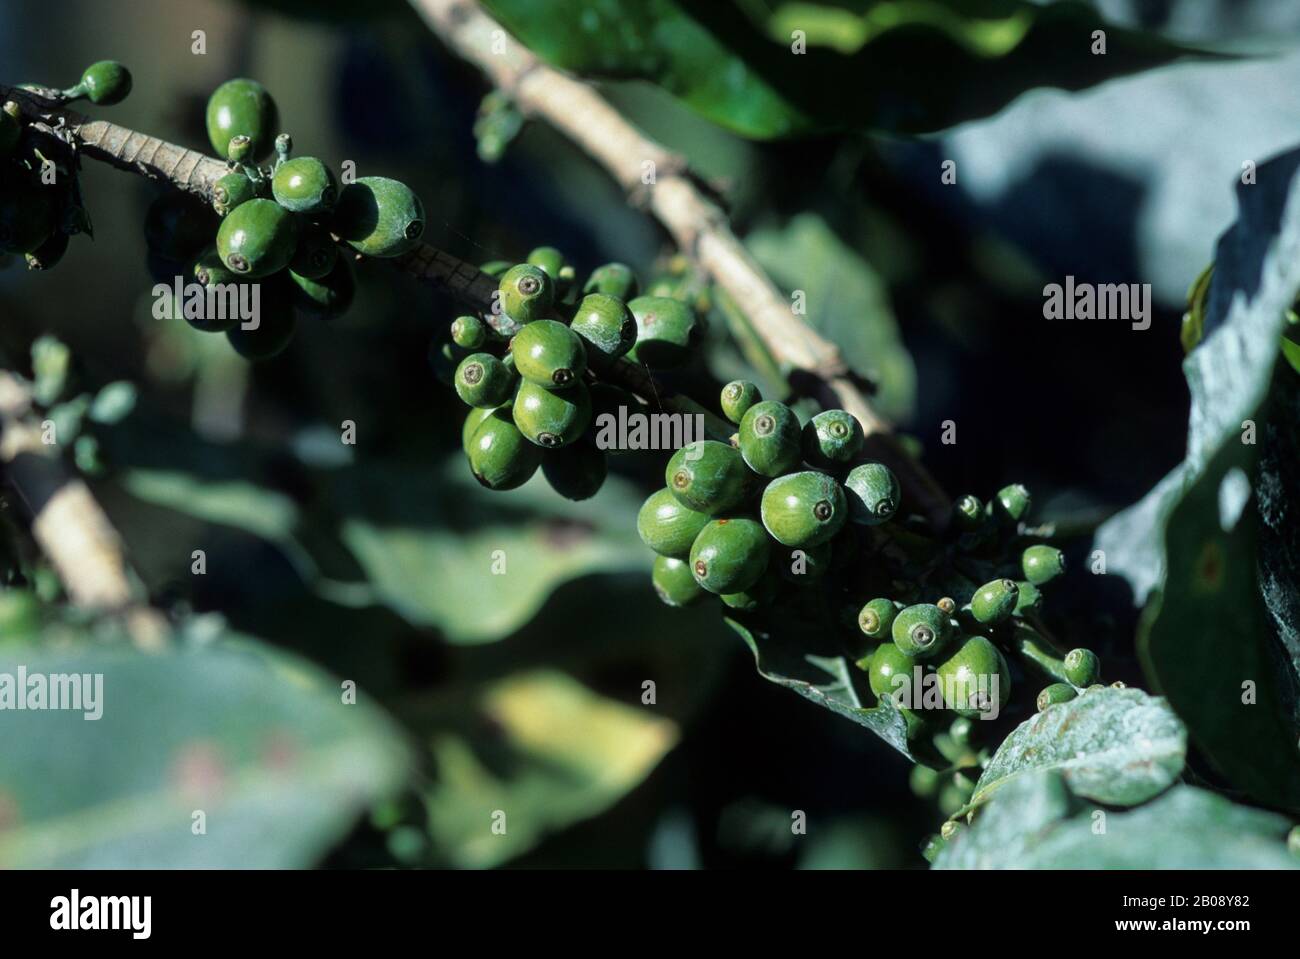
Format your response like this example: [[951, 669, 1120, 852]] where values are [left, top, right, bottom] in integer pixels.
[[935, 769, 1300, 869]]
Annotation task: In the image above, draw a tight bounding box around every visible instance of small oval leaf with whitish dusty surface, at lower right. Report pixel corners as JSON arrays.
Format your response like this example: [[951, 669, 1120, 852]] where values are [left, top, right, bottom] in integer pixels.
[[971, 689, 1187, 806]]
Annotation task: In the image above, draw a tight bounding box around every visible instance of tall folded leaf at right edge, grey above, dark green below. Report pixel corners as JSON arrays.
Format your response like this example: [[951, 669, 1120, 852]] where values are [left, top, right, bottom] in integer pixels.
[[1095, 151, 1300, 810]]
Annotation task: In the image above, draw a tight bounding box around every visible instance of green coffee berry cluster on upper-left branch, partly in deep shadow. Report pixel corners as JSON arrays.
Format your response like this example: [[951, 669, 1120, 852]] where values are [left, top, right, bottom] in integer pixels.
[[146, 79, 425, 360]]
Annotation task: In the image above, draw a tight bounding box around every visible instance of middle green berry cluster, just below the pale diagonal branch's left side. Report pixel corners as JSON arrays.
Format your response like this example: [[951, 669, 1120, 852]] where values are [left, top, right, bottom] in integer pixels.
[[441, 247, 702, 500]]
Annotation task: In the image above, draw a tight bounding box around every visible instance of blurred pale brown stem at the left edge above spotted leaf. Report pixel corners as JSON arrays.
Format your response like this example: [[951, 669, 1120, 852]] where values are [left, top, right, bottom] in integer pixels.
[[0, 370, 168, 650]]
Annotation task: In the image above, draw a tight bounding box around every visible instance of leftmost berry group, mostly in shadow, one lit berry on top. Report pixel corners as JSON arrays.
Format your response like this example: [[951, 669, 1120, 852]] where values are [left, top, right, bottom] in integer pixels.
[[0, 60, 131, 270]]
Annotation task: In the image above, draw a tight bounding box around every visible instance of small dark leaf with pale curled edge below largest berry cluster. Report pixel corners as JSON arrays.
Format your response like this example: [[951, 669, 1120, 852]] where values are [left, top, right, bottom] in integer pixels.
[[727, 617, 914, 759]]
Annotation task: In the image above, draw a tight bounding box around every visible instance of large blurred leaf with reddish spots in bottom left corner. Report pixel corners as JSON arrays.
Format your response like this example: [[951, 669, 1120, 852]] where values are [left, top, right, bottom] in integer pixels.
[[0, 635, 407, 869]]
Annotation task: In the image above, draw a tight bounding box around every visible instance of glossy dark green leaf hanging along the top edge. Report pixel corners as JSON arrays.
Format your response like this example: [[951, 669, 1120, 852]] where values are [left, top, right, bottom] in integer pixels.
[[485, 0, 1183, 139]]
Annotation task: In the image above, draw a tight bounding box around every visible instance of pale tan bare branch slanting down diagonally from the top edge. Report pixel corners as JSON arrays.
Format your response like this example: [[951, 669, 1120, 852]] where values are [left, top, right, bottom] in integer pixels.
[[411, 0, 949, 528]]
